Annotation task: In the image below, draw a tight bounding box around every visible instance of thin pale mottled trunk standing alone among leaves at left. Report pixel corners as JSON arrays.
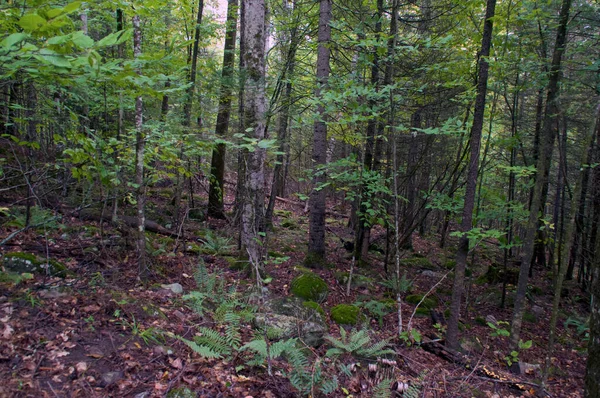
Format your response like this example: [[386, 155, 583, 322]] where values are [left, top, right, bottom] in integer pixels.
[[133, 15, 148, 279]]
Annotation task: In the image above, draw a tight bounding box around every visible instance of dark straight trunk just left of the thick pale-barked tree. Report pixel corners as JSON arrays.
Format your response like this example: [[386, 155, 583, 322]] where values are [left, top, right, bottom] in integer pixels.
[[208, 0, 238, 218]]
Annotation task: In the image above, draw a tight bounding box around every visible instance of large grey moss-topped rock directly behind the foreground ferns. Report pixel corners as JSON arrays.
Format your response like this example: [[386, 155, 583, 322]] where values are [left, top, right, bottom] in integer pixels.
[[254, 298, 327, 347]]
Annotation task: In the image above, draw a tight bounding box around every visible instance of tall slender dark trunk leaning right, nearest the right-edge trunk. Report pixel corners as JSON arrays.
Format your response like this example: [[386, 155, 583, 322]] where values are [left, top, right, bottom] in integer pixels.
[[510, 0, 571, 349]]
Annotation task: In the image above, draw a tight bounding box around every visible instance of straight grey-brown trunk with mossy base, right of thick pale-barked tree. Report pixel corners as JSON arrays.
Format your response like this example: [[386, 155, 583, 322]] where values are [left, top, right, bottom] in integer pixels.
[[306, 0, 331, 267]]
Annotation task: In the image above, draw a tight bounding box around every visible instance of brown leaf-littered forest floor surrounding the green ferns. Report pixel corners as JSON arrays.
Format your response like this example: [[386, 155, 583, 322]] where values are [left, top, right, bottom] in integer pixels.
[[0, 187, 587, 398]]
